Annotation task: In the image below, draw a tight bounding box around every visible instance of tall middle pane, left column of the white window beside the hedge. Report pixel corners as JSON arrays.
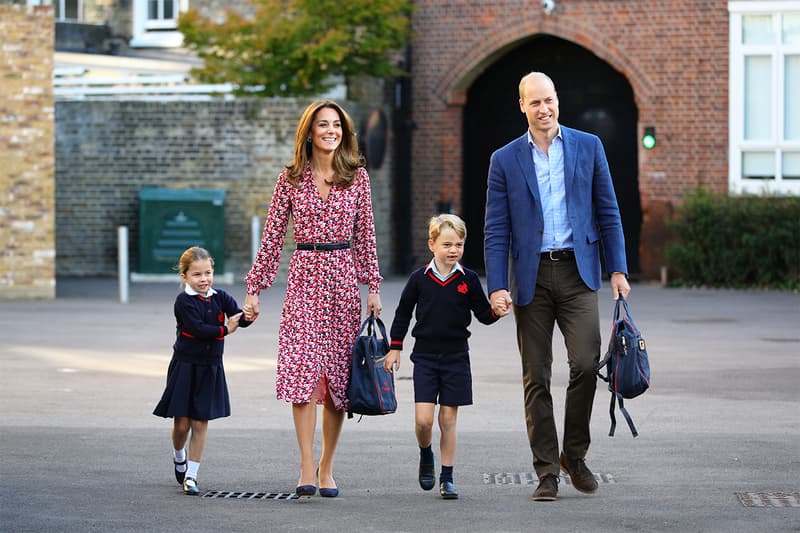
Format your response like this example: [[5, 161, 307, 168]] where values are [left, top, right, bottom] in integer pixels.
[[744, 56, 772, 141]]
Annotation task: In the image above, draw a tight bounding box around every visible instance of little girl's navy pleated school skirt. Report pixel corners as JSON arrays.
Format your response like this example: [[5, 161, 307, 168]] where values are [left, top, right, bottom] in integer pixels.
[[153, 358, 231, 420]]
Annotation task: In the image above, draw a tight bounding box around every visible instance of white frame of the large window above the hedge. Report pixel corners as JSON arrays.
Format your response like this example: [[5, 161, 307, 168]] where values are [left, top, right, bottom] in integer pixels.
[[728, 0, 800, 196]]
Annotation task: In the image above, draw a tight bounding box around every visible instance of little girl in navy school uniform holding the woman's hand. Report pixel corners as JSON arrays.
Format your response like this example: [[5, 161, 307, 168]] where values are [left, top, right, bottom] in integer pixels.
[[153, 246, 250, 495]]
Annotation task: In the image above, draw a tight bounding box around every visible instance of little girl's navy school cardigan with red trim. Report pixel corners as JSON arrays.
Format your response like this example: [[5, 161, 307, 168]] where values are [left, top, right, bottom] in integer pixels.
[[172, 289, 250, 365]]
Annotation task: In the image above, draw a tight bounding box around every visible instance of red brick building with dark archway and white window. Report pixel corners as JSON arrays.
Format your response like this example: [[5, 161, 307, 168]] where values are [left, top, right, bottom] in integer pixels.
[[410, 0, 800, 278]]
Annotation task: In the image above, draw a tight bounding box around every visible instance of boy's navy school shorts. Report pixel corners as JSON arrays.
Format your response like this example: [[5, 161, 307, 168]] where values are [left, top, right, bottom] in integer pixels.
[[411, 352, 472, 407]]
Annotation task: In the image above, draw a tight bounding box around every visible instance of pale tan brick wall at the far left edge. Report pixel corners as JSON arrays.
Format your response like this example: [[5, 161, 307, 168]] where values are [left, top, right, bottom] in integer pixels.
[[0, 4, 55, 299]]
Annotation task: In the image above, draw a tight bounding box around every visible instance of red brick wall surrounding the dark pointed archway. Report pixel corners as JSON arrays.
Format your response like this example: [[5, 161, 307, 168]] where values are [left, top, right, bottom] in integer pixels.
[[412, 0, 728, 277]]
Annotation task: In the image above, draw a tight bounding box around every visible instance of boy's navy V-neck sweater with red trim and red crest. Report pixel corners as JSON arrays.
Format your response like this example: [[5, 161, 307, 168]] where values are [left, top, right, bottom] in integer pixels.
[[390, 265, 499, 353]]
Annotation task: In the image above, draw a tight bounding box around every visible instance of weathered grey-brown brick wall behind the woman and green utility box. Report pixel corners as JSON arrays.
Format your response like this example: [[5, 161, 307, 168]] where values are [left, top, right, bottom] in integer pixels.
[[56, 98, 392, 279]]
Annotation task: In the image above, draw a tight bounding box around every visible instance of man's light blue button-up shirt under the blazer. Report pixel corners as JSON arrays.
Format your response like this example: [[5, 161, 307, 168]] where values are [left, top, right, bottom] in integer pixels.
[[528, 127, 572, 252]]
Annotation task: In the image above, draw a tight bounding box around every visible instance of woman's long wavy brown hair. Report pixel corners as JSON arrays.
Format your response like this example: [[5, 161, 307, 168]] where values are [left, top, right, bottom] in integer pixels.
[[286, 100, 364, 187]]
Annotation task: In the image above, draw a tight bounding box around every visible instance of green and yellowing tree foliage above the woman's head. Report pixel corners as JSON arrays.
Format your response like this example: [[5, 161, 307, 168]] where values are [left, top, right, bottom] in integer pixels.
[[178, 0, 413, 96]]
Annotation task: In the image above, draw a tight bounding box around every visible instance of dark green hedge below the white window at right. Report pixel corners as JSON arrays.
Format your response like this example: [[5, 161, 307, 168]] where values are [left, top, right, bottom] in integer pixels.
[[666, 190, 800, 290]]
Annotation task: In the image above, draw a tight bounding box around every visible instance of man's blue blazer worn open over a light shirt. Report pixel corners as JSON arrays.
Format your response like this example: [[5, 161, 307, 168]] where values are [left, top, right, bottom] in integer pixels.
[[484, 126, 628, 305]]
